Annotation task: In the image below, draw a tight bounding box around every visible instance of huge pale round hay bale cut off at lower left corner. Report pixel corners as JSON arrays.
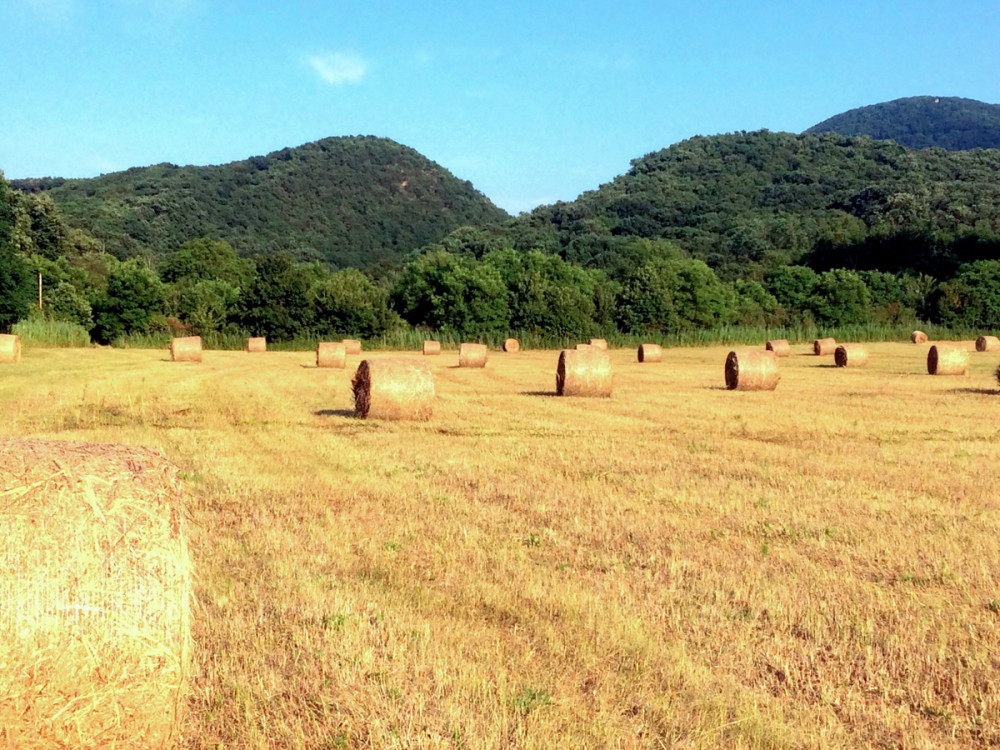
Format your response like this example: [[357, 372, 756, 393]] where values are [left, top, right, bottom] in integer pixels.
[[0, 438, 191, 750]]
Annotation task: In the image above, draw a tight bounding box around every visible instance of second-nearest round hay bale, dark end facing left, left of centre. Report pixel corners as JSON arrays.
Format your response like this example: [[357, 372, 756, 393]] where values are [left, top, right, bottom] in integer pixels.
[[351, 358, 434, 421]]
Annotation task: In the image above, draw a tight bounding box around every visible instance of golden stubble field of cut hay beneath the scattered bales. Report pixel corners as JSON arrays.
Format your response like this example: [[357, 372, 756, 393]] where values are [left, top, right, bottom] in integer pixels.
[[0, 343, 1000, 750]]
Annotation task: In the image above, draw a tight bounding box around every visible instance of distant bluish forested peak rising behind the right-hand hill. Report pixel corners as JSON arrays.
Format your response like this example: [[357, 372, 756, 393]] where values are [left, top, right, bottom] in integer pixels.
[[806, 96, 1000, 151]]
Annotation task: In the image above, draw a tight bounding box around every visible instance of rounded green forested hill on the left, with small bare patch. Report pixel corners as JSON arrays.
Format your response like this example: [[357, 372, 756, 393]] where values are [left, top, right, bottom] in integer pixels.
[[12, 136, 509, 268]]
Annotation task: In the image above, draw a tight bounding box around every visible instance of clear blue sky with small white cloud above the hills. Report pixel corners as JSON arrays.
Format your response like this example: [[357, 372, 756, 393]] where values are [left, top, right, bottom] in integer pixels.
[[0, 0, 1000, 213]]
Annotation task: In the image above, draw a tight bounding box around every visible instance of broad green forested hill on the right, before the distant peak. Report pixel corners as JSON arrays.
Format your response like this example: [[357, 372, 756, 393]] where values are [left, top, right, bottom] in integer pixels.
[[514, 131, 1000, 279]]
